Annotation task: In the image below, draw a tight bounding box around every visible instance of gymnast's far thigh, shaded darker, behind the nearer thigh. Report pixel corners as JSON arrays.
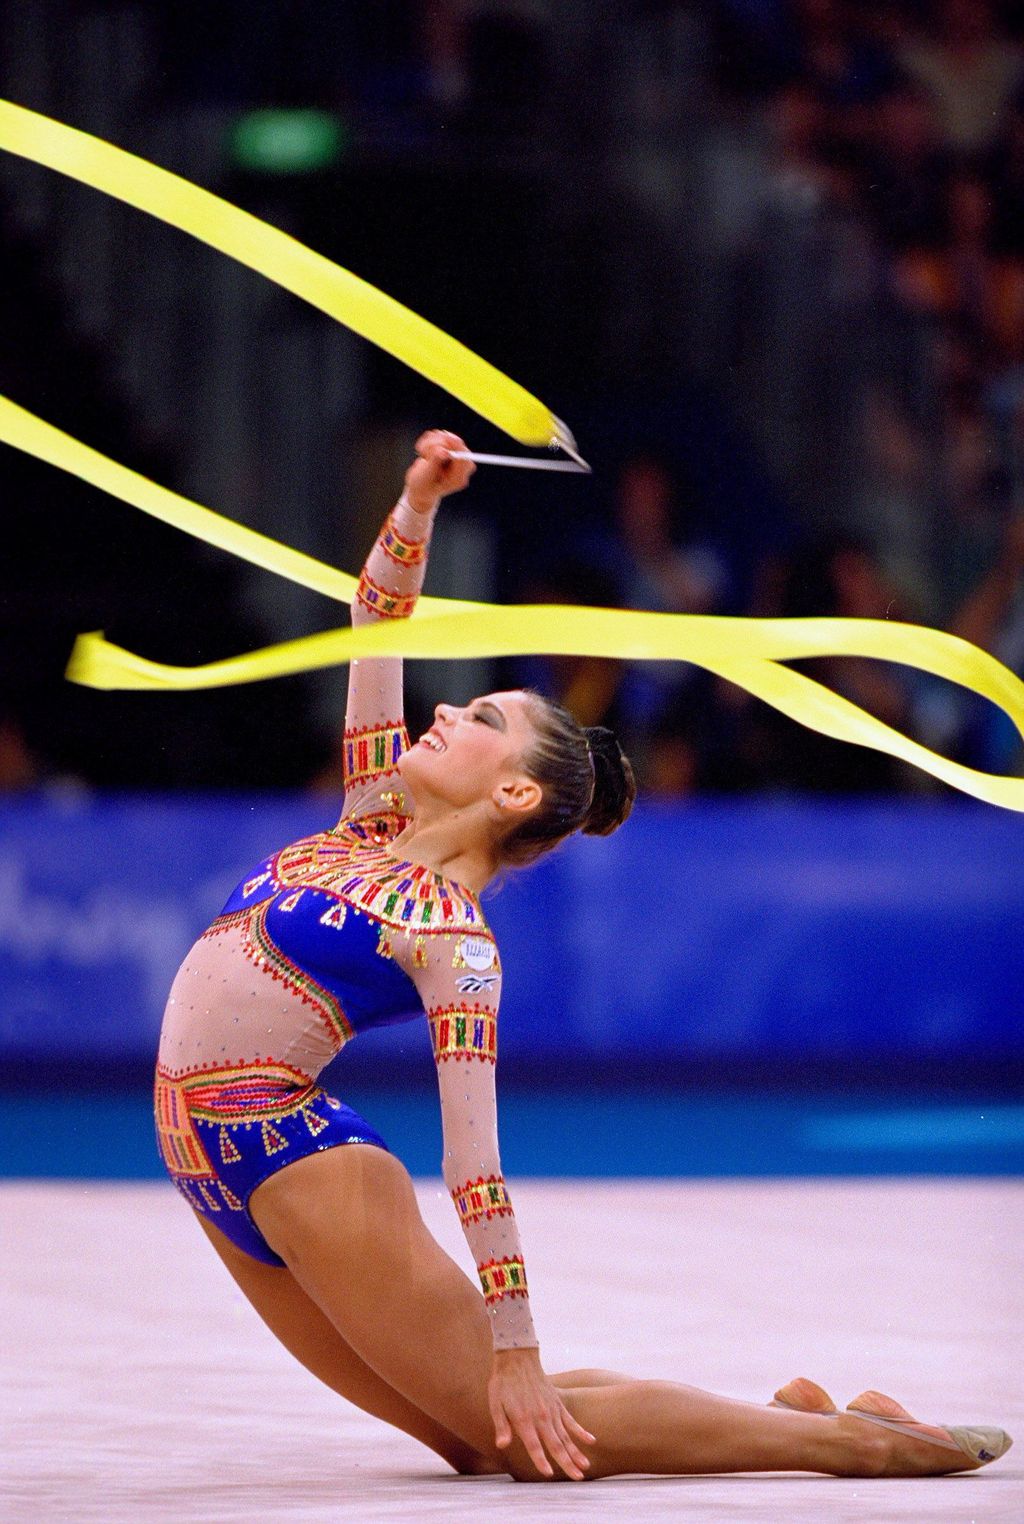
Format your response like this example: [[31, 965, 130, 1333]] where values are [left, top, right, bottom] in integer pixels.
[[195, 1212, 500, 1475]]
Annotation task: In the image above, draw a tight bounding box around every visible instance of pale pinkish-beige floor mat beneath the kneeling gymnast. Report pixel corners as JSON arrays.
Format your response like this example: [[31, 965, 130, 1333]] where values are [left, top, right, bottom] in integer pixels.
[[0, 1180, 1024, 1524]]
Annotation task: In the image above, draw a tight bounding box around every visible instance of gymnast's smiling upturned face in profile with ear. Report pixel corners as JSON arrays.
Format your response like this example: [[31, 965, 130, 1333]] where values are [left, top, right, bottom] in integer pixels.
[[398, 689, 541, 824]]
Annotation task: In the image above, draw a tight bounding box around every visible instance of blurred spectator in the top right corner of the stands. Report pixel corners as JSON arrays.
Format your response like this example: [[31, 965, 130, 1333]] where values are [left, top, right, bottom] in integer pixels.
[[899, 0, 1024, 157]]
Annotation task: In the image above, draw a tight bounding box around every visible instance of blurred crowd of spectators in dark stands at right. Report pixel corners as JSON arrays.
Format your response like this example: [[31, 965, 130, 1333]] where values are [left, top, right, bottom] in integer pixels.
[[508, 0, 1024, 796]]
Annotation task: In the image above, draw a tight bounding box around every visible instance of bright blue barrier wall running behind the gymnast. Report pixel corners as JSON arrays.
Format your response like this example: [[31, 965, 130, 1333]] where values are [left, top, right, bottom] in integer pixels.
[[0, 796, 1024, 1081]]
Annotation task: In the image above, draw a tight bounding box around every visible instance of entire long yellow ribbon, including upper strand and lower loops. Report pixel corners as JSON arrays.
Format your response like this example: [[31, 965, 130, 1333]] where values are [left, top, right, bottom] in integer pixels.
[[0, 102, 1024, 811]]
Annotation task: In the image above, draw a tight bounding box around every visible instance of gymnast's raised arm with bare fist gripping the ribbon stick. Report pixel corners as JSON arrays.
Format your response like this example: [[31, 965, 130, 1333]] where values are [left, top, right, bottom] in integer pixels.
[[343, 428, 477, 815]]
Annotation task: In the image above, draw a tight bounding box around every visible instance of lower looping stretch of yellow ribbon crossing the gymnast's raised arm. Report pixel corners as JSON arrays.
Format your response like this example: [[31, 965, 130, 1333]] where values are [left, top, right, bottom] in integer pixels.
[[8, 387, 1024, 811]]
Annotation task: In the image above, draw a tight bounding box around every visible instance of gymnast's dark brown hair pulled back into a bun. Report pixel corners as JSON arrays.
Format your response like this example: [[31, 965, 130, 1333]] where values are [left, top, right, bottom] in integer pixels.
[[500, 689, 637, 867]]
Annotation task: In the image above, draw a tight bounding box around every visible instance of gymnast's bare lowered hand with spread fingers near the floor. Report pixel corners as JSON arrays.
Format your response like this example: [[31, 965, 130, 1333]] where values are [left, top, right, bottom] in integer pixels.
[[488, 1349, 596, 1481]]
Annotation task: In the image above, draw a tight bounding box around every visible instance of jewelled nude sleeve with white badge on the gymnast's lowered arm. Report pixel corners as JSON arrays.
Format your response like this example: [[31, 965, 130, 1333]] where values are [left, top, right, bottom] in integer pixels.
[[413, 927, 536, 1349]]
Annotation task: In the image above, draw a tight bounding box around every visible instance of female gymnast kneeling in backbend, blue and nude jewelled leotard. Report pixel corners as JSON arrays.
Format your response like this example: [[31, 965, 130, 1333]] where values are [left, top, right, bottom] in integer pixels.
[[155, 431, 1010, 1480]]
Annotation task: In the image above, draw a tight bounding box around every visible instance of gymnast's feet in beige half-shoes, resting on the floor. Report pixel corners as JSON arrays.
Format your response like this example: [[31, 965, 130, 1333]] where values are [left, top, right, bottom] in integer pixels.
[[770, 1376, 1013, 1477]]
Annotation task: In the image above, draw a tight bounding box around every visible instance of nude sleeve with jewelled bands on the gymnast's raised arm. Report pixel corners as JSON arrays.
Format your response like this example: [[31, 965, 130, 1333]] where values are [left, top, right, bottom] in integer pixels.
[[343, 497, 434, 815]]
